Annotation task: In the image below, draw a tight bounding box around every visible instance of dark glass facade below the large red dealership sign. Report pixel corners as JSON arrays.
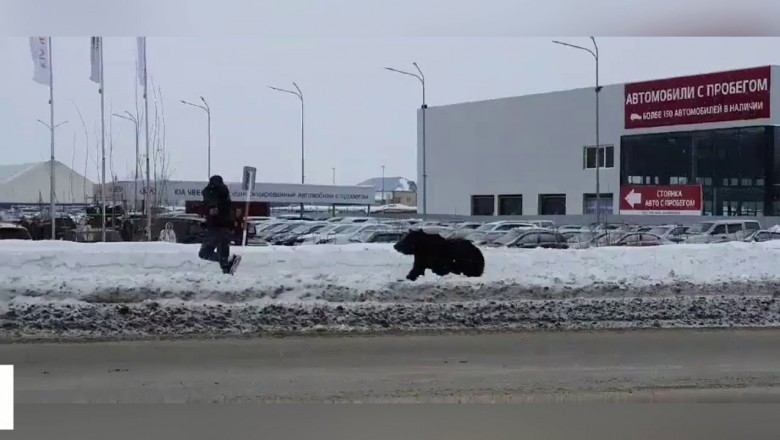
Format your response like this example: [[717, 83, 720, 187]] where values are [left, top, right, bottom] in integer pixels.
[[620, 126, 780, 216]]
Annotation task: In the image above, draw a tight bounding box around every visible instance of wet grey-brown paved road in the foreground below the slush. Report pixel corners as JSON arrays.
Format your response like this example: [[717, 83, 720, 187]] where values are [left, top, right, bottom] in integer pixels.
[[0, 330, 780, 403]]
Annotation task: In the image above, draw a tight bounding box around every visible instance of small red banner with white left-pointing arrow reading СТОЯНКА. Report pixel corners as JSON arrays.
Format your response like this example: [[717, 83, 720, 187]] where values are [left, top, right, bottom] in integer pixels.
[[620, 185, 704, 215]]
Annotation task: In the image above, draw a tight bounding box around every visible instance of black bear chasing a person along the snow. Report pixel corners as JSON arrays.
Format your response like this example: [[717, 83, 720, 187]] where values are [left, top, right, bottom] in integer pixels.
[[393, 229, 485, 281]]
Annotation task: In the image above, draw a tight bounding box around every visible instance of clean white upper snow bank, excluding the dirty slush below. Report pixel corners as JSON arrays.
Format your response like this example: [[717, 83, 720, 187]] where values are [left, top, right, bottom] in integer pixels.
[[0, 237, 780, 303]]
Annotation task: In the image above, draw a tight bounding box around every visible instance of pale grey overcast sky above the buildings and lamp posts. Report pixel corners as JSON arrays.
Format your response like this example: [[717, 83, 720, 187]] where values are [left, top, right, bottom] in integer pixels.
[[0, 37, 780, 184]]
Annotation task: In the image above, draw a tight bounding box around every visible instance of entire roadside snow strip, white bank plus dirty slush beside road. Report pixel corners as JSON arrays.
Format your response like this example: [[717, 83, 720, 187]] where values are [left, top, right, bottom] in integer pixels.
[[0, 241, 780, 338]]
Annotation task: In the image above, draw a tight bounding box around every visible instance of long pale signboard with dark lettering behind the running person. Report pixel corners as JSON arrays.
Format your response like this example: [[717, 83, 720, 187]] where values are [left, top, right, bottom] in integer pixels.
[[95, 181, 374, 205]]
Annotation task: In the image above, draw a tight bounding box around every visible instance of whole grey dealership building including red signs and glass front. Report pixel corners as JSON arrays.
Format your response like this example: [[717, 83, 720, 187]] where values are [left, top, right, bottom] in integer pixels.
[[418, 66, 780, 216]]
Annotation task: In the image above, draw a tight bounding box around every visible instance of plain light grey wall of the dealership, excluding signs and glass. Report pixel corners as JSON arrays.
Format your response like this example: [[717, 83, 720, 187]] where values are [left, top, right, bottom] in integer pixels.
[[417, 66, 780, 215]]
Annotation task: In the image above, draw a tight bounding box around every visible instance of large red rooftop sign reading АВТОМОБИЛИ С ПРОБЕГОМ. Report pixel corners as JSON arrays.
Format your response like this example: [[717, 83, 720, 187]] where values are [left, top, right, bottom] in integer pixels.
[[624, 66, 772, 129]]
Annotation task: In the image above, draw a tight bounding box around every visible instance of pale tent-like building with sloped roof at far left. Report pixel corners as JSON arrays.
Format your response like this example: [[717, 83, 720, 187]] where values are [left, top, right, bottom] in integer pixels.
[[0, 160, 94, 204]]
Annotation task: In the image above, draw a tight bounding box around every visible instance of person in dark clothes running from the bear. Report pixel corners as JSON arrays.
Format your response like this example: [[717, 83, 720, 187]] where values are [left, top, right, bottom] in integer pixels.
[[198, 175, 241, 275]]
